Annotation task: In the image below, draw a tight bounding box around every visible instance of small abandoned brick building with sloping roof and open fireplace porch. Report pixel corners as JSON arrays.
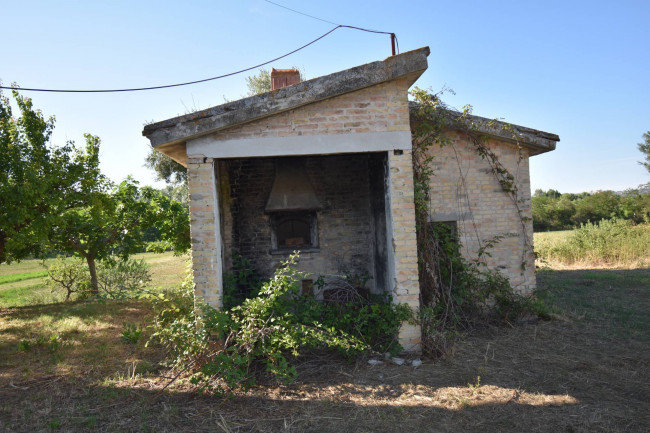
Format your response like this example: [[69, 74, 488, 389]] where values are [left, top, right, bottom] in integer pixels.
[[143, 48, 559, 351]]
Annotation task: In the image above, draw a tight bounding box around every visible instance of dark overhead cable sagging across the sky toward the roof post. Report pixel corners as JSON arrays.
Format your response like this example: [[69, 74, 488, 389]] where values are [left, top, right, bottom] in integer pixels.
[[0, 21, 394, 93]]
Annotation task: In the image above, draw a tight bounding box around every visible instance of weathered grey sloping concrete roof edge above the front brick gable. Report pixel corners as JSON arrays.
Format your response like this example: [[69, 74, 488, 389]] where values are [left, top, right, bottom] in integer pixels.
[[142, 47, 430, 147]]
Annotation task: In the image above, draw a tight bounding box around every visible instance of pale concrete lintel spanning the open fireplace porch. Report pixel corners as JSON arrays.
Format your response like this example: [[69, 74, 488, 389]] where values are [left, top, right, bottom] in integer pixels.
[[187, 131, 411, 158]]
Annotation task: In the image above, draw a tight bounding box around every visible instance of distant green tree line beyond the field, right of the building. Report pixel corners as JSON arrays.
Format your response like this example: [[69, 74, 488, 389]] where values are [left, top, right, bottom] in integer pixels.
[[532, 184, 650, 231]]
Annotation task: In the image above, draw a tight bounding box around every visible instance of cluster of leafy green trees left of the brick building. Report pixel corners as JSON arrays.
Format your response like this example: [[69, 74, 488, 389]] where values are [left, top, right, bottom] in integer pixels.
[[0, 90, 189, 293]]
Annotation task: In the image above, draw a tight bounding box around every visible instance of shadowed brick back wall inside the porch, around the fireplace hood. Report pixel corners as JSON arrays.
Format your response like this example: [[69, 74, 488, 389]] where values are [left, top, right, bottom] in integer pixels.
[[222, 154, 379, 288]]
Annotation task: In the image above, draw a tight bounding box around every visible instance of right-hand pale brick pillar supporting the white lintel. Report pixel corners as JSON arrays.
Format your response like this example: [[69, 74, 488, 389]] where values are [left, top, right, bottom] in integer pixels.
[[386, 150, 422, 353]]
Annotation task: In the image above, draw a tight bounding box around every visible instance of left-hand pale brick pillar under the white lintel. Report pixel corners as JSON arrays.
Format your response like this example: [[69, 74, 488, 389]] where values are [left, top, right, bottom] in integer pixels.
[[187, 157, 223, 309]]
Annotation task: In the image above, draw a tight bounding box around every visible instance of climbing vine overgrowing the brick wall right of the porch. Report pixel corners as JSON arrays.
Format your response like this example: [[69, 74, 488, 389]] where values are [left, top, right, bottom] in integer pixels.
[[411, 88, 540, 354]]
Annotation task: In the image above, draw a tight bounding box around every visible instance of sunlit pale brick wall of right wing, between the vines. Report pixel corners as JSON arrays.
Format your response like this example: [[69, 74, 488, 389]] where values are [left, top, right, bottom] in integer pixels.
[[430, 132, 535, 294]]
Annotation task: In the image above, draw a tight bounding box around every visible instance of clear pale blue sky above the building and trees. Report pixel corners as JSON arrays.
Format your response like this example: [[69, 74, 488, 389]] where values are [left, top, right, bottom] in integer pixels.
[[0, 0, 650, 192]]
